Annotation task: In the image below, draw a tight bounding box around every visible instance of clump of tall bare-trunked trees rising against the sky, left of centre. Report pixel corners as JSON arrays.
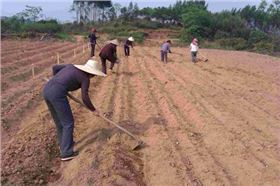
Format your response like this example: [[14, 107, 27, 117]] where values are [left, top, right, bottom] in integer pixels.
[[73, 0, 106, 23]]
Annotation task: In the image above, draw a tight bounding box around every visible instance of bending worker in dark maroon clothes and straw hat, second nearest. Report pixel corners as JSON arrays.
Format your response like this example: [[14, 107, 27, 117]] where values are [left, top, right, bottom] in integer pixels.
[[99, 39, 119, 74]]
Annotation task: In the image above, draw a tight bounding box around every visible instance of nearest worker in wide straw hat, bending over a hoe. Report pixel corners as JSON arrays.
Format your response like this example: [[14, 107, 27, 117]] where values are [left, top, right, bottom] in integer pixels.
[[43, 60, 106, 161]]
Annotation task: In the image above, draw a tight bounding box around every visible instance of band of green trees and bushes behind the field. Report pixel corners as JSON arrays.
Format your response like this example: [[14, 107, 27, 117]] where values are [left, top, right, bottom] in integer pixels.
[[1, 0, 280, 54]]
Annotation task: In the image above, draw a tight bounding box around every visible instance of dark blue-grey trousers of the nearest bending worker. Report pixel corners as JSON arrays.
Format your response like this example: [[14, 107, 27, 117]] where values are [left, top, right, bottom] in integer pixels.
[[43, 81, 74, 156]]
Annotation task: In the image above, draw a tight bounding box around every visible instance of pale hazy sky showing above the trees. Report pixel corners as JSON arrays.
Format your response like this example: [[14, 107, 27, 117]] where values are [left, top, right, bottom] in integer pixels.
[[0, 0, 271, 22]]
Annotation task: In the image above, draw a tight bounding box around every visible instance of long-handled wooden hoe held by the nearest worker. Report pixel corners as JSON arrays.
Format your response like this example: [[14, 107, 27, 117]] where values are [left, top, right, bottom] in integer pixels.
[[44, 78, 144, 150]]
